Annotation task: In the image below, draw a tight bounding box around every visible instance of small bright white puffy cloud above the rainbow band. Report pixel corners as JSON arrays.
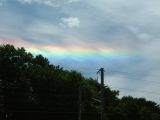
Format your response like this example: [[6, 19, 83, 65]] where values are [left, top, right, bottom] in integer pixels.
[[60, 17, 80, 28]]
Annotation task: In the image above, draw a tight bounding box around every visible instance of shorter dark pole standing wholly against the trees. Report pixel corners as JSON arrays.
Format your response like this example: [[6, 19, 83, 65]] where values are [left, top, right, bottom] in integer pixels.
[[78, 85, 82, 120]]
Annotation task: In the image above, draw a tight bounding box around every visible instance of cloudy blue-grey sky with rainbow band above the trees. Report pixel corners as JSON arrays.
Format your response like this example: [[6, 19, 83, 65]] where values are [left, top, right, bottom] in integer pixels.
[[0, 0, 160, 103]]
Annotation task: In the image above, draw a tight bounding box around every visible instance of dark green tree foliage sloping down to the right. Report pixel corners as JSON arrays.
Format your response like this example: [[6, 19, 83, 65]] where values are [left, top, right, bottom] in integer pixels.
[[0, 45, 160, 120]]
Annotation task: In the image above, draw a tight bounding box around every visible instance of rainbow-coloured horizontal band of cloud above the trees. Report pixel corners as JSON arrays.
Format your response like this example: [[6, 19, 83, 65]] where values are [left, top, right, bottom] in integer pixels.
[[0, 38, 141, 60]]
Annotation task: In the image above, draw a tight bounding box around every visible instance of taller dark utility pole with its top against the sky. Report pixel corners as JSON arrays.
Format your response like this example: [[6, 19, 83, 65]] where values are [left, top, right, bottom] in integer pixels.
[[97, 68, 104, 120]]
